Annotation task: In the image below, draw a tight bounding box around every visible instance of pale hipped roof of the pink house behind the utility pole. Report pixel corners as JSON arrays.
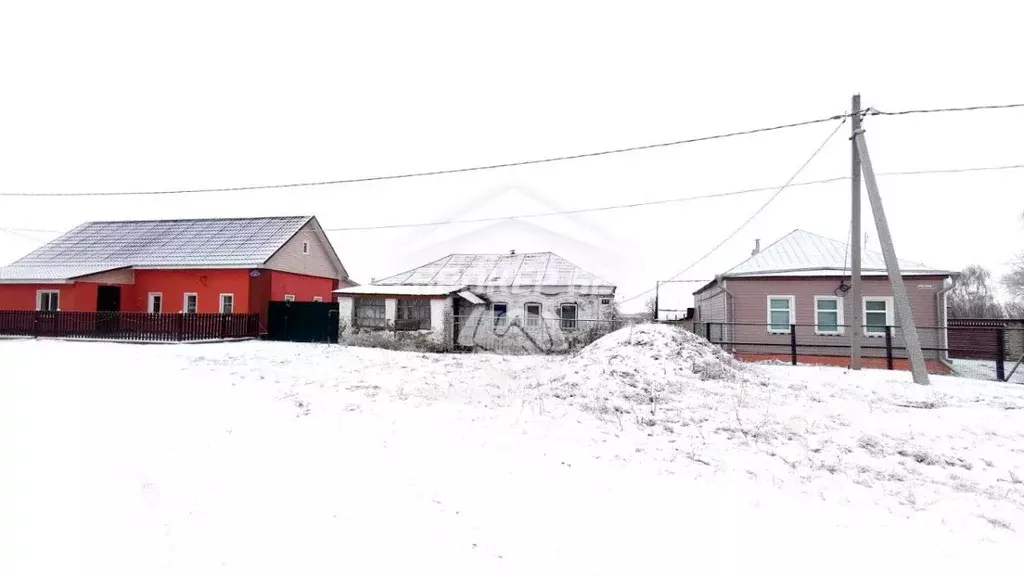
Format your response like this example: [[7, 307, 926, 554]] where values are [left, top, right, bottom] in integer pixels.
[[722, 230, 951, 278]]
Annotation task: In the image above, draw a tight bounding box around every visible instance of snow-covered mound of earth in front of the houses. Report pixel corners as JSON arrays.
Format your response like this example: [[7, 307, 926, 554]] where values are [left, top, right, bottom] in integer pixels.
[[549, 324, 759, 431]]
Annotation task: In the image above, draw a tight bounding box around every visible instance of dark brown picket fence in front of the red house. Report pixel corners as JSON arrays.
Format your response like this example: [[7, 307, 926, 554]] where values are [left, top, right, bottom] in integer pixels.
[[0, 311, 259, 342]]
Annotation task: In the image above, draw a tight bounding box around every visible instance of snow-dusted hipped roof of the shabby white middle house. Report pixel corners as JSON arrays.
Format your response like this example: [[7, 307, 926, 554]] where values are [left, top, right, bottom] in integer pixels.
[[375, 252, 614, 290]]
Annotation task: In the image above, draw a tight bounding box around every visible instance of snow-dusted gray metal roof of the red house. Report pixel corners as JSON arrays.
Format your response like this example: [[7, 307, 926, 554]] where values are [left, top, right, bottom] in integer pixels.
[[0, 216, 312, 280]]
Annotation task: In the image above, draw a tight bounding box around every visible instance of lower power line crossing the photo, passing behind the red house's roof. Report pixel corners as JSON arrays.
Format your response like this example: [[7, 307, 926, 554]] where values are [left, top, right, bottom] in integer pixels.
[[2, 158, 1024, 234]]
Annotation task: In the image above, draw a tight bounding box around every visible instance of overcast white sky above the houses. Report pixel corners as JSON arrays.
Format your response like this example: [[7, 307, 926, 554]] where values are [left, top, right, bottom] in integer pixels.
[[0, 0, 1024, 307]]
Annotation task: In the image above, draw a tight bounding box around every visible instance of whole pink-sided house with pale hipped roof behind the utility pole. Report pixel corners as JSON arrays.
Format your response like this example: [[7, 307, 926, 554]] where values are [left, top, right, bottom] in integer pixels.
[[694, 230, 955, 372]]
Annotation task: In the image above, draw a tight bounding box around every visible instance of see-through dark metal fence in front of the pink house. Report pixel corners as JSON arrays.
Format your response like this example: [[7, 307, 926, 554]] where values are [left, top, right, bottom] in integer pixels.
[[693, 323, 1024, 383]]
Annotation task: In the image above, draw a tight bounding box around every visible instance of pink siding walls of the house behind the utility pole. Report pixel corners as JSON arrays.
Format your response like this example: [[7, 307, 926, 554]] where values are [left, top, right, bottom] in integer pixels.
[[695, 276, 945, 360]]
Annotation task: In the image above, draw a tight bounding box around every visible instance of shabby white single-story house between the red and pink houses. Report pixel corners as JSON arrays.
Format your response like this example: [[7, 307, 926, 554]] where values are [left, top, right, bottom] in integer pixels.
[[335, 252, 615, 349]]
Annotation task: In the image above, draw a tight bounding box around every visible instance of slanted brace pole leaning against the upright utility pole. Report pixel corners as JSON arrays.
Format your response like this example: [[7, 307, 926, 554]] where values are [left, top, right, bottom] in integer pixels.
[[853, 129, 929, 384]]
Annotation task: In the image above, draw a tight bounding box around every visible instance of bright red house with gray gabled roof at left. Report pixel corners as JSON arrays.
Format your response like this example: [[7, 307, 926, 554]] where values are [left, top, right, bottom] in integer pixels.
[[0, 216, 354, 331]]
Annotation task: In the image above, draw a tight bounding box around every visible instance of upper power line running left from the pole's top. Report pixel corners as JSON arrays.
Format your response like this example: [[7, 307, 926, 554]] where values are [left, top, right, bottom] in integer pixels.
[[0, 114, 849, 198]]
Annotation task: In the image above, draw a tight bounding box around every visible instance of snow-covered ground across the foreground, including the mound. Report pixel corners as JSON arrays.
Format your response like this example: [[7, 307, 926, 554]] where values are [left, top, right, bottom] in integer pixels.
[[0, 326, 1024, 575]]
